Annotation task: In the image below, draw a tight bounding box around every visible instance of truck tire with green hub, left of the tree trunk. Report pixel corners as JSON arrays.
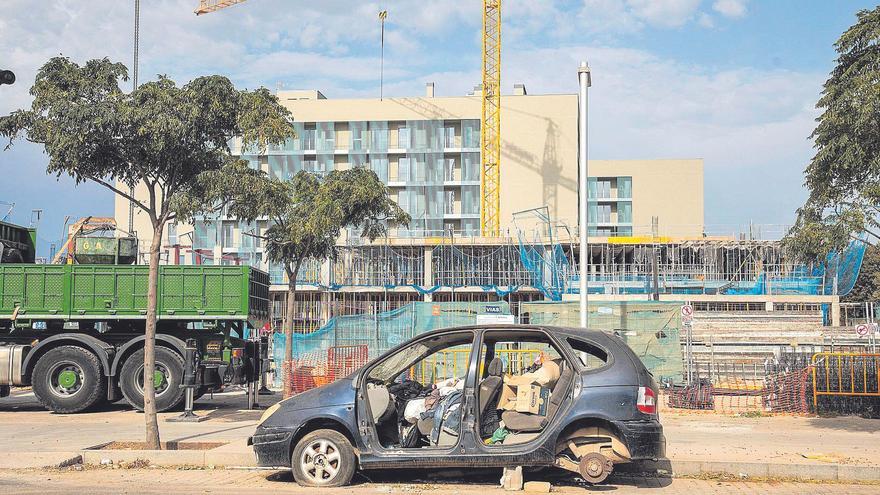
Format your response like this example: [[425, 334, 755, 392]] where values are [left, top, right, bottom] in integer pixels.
[[31, 345, 107, 414]]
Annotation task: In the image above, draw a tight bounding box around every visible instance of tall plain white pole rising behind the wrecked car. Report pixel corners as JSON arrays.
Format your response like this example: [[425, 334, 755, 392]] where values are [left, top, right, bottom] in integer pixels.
[[578, 62, 592, 328]]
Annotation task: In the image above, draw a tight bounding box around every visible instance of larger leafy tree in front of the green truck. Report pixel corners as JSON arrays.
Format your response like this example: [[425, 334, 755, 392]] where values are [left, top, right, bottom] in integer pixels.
[[0, 57, 294, 449]]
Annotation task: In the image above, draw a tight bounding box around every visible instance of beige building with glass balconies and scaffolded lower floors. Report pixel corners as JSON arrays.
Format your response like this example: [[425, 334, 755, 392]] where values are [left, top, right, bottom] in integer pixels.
[[116, 84, 860, 331]]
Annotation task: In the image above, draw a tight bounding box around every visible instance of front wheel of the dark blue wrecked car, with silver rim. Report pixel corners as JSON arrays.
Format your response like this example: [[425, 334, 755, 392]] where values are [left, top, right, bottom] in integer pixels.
[[290, 430, 357, 488]]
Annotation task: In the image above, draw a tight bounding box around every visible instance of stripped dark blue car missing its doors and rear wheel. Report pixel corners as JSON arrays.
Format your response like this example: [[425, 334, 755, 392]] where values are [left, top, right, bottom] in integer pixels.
[[249, 325, 666, 487]]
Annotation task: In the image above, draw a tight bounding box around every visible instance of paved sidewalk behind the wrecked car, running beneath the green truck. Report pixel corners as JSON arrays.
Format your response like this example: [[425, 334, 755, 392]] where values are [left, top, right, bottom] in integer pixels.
[[0, 392, 880, 479]]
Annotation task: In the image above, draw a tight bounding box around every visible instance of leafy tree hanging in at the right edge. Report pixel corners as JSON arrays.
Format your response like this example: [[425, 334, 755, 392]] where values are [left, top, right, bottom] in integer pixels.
[[785, 7, 880, 261]]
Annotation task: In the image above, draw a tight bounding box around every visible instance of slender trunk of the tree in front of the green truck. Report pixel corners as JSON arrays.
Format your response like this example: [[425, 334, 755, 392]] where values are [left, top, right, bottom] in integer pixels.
[[144, 221, 165, 450]]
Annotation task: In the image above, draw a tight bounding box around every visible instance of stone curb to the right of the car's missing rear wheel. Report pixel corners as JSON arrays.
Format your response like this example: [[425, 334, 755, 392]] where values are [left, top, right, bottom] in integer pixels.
[[661, 459, 880, 481]]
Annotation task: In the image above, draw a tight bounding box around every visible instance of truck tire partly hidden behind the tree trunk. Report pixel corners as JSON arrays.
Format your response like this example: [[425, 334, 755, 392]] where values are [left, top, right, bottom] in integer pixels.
[[119, 347, 184, 412]]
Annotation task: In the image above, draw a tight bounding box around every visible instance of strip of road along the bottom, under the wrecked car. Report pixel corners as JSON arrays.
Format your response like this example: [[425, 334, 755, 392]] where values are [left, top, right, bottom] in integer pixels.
[[0, 468, 880, 495]]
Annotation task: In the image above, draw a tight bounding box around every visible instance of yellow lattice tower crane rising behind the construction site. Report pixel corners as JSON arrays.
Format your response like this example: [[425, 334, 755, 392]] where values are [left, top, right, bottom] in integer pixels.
[[195, 0, 501, 237]]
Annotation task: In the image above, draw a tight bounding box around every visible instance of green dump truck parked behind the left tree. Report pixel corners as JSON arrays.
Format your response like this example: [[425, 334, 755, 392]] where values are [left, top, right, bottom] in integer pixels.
[[0, 264, 269, 413]]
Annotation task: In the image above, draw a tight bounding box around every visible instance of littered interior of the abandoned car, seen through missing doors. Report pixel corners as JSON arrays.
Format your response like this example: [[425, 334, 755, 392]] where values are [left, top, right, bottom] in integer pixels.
[[366, 331, 575, 448]]
